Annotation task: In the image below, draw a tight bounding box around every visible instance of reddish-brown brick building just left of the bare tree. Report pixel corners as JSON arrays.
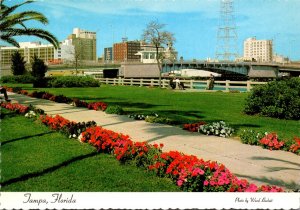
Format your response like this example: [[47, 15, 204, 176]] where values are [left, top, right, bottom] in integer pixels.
[[113, 41, 141, 62]]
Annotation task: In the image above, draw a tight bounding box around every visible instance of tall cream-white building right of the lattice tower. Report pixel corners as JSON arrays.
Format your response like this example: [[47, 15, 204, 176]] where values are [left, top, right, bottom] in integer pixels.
[[244, 37, 273, 62]]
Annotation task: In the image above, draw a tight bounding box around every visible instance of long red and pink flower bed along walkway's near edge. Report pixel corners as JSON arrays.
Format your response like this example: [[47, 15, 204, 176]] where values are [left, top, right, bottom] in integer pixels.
[[1, 103, 283, 192]]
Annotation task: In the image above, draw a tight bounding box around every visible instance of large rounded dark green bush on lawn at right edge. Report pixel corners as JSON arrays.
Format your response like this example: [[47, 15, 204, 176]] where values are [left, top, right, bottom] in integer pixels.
[[244, 78, 300, 120]]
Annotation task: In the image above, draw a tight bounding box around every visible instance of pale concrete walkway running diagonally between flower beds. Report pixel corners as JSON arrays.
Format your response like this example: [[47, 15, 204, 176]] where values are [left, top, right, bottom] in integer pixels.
[[9, 93, 300, 190]]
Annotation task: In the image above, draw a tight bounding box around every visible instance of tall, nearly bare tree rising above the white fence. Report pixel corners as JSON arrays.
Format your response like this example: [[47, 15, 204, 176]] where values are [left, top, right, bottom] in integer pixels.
[[142, 21, 175, 87]]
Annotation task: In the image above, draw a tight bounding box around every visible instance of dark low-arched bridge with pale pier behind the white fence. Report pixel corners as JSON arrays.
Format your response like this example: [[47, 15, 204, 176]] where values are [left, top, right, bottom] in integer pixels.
[[163, 61, 300, 77]]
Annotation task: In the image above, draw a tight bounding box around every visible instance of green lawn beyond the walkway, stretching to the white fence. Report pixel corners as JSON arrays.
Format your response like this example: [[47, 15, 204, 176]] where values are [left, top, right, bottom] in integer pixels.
[[4, 84, 300, 139]]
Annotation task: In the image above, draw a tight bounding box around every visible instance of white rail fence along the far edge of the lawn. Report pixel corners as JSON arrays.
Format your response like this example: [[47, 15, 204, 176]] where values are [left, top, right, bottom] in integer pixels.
[[96, 77, 266, 92]]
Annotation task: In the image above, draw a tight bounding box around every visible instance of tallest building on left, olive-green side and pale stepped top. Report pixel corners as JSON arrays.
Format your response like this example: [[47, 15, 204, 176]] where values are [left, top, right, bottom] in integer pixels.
[[68, 28, 97, 61]]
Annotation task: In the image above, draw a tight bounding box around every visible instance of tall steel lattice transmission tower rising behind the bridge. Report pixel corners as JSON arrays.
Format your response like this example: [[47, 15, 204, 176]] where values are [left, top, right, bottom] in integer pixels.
[[216, 0, 238, 61]]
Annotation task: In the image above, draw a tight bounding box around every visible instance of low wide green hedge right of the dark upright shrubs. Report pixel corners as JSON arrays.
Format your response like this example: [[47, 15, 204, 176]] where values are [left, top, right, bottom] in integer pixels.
[[48, 76, 100, 88]]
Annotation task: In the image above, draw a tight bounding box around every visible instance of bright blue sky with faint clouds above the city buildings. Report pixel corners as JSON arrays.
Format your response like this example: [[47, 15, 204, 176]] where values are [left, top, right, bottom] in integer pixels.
[[0, 0, 300, 60]]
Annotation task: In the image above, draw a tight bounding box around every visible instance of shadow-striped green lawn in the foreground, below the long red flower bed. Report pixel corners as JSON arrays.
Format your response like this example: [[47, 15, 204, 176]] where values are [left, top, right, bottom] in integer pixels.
[[0, 109, 179, 192]]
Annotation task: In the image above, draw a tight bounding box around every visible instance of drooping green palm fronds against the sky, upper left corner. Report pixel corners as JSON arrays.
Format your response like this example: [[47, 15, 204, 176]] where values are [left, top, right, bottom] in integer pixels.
[[0, 0, 59, 48]]
